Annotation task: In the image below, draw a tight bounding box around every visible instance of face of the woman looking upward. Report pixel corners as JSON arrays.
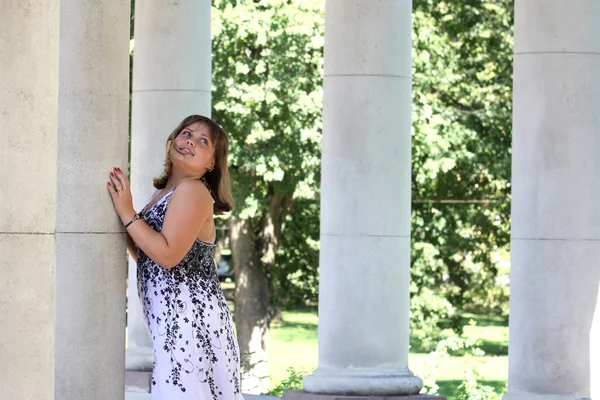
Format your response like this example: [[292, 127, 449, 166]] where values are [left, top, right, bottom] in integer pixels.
[[171, 122, 215, 176]]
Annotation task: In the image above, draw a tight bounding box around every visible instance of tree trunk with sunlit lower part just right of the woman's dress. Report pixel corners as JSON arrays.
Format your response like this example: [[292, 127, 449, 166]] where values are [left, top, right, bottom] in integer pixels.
[[229, 217, 269, 394]]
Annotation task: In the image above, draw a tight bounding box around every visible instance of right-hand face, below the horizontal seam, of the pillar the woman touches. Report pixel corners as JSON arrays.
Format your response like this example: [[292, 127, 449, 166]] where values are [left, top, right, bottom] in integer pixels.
[[55, 233, 126, 400]]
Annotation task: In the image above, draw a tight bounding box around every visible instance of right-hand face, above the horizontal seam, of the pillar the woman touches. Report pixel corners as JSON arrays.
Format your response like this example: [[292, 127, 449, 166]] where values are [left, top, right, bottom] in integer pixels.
[[56, 0, 130, 233]]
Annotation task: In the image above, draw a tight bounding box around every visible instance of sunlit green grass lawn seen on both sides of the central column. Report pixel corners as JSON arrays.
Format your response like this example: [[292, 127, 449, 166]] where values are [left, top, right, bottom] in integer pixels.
[[269, 311, 508, 400]]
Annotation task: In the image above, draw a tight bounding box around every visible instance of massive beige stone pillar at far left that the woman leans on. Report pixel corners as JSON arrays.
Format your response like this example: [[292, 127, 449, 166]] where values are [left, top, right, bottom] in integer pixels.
[[0, 0, 129, 400]]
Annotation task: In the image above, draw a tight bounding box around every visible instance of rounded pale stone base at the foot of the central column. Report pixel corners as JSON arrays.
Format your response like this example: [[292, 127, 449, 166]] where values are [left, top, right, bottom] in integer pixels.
[[302, 367, 423, 397]]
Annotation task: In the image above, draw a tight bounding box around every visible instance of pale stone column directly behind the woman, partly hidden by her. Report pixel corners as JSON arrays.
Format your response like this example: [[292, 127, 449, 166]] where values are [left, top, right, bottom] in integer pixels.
[[127, 0, 212, 378]]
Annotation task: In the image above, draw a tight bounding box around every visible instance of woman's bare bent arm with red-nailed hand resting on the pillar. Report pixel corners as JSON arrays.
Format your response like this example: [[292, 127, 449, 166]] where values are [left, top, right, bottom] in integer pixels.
[[108, 170, 213, 269]]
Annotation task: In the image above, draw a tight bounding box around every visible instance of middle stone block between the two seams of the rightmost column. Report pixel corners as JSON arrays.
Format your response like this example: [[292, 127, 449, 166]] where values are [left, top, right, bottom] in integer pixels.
[[512, 54, 600, 240]]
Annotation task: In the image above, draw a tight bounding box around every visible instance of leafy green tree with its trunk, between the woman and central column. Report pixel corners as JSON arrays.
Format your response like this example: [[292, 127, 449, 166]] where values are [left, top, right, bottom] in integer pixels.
[[212, 0, 324, 384]]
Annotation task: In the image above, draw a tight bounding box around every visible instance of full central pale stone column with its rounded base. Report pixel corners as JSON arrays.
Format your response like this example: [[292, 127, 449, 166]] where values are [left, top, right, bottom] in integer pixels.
[[304, 0, 422, 396]]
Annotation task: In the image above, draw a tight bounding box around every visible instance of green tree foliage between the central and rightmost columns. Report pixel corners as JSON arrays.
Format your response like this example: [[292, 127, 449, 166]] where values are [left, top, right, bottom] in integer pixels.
[[411, 0, 513, 338]]
